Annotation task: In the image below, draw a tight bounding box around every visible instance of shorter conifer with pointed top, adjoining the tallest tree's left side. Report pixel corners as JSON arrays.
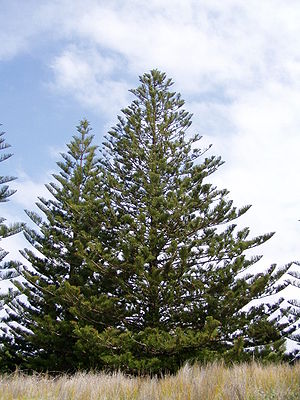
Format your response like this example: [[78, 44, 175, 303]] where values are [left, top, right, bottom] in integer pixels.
[[2, 120, 120, 372]]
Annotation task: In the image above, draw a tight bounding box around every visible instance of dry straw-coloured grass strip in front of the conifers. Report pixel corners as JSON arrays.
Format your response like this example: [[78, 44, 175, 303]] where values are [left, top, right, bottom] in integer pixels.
[[0, 364, 300, 400]]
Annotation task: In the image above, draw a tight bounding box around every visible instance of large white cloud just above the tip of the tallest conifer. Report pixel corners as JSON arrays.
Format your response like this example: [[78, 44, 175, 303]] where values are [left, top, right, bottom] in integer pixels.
[[45, 1, 299, 93]]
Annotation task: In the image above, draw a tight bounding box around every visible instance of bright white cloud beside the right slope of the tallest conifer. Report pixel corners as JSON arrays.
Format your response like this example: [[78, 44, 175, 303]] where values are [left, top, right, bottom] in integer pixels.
[[212, 82, 300, 263]]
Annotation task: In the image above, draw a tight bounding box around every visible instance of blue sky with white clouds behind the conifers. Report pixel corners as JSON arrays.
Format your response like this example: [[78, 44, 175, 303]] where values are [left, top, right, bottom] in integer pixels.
[[0, 0, 300, 344]]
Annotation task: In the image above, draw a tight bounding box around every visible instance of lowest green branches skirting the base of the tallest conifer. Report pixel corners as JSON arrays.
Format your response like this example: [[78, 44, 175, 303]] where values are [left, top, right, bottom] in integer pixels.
[[75, 318, 219, 375]]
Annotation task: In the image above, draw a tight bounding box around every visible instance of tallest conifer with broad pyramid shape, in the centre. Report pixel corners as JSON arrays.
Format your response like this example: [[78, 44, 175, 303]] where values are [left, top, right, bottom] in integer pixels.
[[71, 70, 286, 372]]
